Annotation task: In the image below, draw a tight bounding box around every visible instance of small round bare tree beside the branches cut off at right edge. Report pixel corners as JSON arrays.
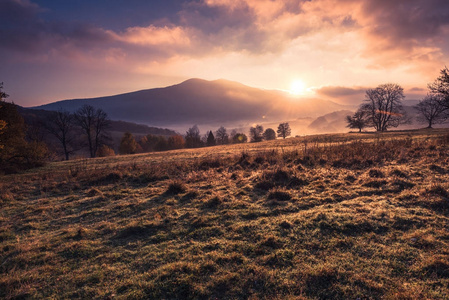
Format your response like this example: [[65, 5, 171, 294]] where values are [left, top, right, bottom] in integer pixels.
[[414, 94, 448, 128]]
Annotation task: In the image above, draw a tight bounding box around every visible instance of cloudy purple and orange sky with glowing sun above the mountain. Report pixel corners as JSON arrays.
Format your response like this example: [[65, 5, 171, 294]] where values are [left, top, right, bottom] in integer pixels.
[[0, 0, 449, 107]]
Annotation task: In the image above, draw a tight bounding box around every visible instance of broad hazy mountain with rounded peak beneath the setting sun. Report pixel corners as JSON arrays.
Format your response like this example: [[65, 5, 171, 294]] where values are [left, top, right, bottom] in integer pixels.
[[35, 79, 347, 128]]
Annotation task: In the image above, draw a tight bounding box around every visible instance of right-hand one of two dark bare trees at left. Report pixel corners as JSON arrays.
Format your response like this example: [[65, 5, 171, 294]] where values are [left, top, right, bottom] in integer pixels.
[[75, 104, 109, 157]]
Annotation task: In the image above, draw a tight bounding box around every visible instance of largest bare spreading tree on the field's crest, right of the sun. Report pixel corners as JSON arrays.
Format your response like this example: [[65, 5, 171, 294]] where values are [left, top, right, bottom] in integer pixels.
[[361, 83, 406, 131]]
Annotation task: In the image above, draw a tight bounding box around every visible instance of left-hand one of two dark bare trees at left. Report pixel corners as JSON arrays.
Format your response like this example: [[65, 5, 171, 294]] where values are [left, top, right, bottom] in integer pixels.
[[45, 109, 76, 160]]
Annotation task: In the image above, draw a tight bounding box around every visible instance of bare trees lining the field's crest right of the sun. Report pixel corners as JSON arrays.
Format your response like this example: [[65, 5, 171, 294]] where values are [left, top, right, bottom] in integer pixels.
[[346, 67, 449, 132]]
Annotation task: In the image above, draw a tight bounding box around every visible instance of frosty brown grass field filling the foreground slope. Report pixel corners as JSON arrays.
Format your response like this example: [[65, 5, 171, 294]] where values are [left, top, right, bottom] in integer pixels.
[[0, 129, 449, 299]]
